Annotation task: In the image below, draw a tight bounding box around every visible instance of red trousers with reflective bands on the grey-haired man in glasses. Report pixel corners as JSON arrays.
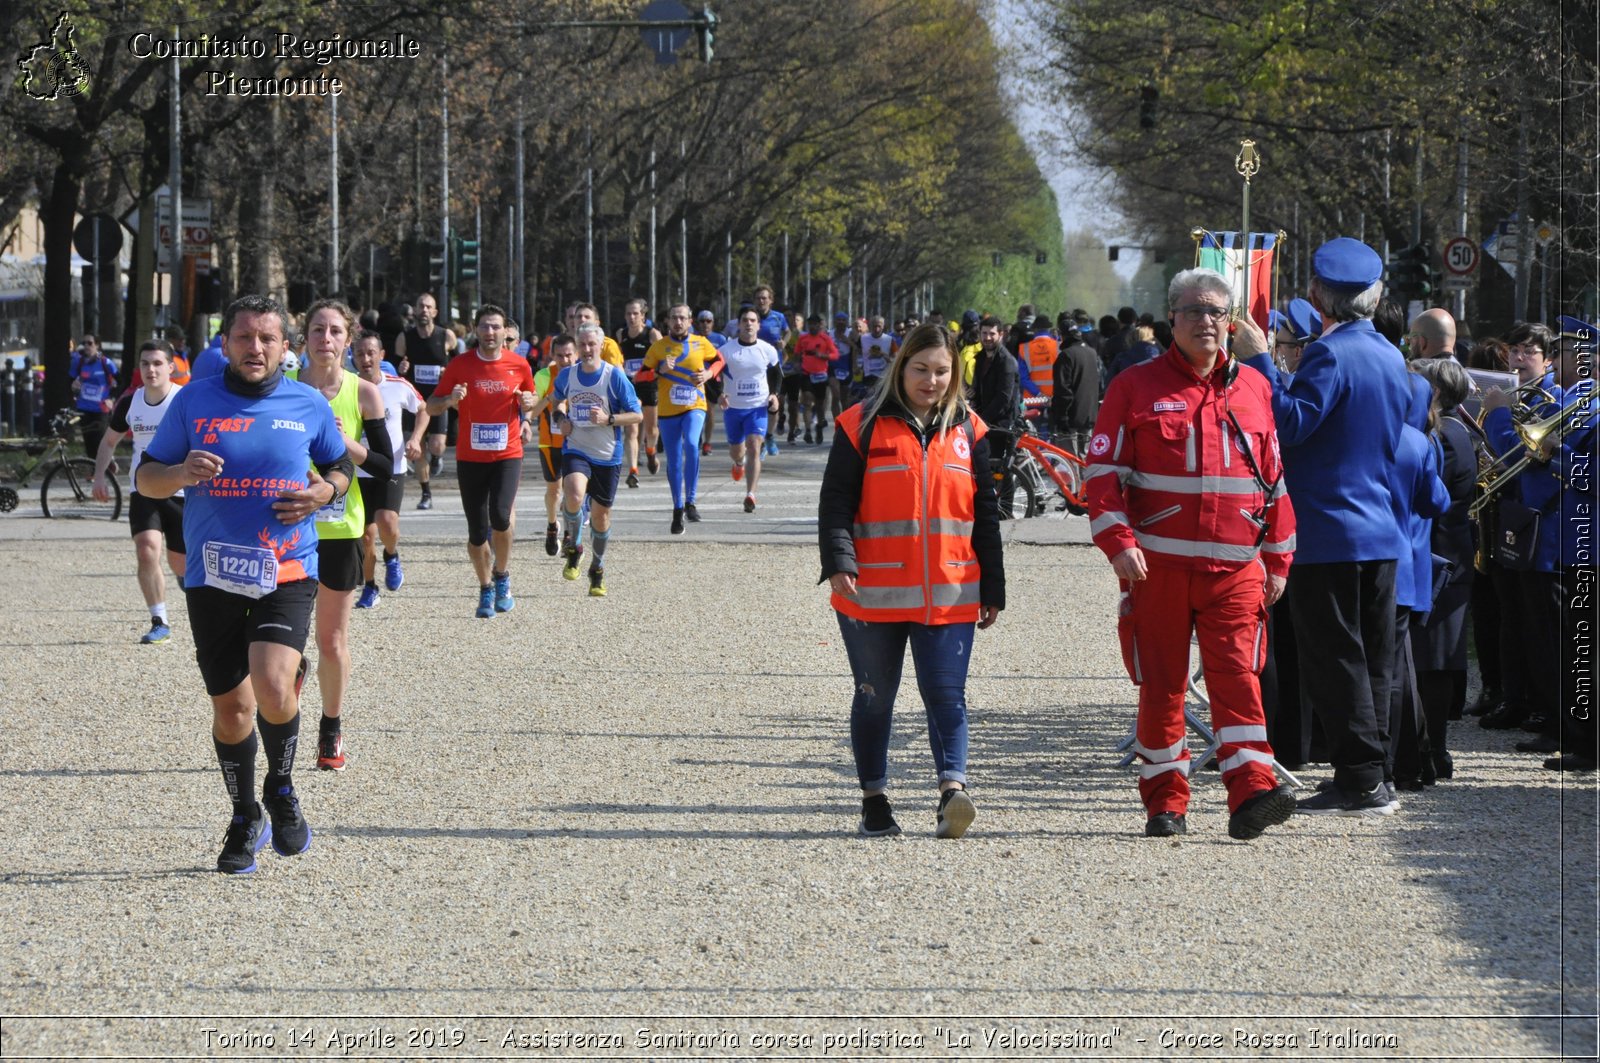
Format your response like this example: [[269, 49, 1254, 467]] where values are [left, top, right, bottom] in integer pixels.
[[1117, 556, 1277, 816]]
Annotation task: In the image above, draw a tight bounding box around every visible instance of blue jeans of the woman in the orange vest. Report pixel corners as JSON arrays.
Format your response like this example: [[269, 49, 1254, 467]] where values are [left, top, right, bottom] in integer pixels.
[[835, 613, 976, 789]]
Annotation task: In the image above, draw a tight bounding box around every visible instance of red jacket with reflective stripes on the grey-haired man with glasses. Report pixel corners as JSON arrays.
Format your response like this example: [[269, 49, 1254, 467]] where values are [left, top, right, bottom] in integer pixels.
[[1085, 346, 1294, 576]]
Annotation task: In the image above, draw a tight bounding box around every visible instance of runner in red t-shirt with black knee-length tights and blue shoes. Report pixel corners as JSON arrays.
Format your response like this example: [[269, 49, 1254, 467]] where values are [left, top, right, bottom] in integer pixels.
[[427, 304, 534, 620]]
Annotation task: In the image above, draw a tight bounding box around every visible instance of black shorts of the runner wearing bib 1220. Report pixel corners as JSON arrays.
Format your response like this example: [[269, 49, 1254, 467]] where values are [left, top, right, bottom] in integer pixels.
[[184, 580, 317, 698]]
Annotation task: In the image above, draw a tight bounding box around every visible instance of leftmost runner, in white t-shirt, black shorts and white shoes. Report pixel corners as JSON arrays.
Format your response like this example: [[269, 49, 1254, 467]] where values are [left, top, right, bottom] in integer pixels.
[[94, 339, 184, 645]]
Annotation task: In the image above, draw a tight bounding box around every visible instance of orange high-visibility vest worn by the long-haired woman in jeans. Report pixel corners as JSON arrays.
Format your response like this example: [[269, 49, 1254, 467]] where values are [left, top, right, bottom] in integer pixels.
[[832, 403, 989, 624]]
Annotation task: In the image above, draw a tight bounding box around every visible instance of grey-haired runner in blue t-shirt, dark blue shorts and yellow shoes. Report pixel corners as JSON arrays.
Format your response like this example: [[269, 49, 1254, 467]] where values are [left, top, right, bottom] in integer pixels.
[[528, 323, 645, 597]]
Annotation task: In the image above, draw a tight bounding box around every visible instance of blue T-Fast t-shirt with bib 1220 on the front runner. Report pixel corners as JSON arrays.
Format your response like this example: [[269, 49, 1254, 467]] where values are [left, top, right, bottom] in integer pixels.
[[144, 376, 346, 597]]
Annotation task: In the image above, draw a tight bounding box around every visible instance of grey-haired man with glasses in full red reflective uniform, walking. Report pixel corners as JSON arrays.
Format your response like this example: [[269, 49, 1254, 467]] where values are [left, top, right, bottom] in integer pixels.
[[1086, 269, 1294, 840]]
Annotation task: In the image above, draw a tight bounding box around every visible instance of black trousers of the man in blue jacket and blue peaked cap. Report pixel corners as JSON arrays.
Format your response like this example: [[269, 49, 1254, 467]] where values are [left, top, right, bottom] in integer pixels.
[[1288, 560, 1395, 792]]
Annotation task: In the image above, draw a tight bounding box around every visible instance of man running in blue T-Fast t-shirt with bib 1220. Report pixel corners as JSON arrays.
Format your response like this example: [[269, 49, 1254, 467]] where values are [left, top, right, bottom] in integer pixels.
[[136, 296, 355, 874]]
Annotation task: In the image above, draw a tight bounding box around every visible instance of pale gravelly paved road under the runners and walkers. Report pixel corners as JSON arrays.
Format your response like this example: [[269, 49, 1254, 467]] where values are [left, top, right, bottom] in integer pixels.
[[0, 448, 1597, 1058]]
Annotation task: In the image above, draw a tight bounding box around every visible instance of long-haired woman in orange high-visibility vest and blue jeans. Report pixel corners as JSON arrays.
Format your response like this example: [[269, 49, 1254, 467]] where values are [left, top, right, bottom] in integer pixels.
[[818, 323, 1005, 837]]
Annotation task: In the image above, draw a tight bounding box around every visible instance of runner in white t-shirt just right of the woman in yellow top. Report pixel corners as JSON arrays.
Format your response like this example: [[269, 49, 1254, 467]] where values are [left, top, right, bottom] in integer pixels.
[[355, 331, 430, 608]]
